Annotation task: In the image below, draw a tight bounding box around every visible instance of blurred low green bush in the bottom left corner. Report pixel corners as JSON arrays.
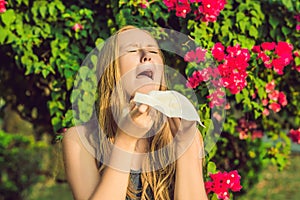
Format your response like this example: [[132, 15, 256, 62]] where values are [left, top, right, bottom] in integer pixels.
[[0, 130, 47, 200]]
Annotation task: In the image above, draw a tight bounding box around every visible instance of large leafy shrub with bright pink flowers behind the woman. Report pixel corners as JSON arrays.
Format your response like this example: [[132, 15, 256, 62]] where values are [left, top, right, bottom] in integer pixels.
[[0, 0, 300, 198]]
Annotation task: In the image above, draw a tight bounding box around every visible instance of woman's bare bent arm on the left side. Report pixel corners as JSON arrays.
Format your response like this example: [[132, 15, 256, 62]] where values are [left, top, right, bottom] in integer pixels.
[[63, 104, 151, 200]]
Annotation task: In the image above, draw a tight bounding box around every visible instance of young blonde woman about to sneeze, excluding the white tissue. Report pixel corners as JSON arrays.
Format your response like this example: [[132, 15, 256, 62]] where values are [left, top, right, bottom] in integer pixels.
[[63, 26, 207, 200]]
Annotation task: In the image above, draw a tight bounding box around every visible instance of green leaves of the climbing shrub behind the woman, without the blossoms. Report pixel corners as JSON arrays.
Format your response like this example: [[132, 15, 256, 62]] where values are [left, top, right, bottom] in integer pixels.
[[0, 0, 300, 198]]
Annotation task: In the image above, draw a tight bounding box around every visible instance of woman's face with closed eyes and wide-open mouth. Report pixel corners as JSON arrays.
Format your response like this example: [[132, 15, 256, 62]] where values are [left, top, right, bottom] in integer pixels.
[[118, 29, 163, 97]]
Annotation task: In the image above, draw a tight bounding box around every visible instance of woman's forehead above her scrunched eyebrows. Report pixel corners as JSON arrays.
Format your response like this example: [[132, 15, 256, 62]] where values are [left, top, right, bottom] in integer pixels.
[[118, 29, 158, 48]]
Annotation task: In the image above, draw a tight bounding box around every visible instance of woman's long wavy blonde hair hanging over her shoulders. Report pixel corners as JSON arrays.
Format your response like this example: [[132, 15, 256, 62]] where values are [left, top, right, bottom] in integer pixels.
[[96, 26, 175, 200]]
